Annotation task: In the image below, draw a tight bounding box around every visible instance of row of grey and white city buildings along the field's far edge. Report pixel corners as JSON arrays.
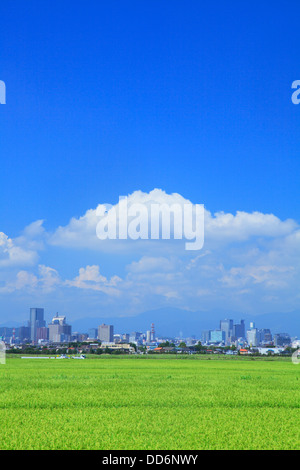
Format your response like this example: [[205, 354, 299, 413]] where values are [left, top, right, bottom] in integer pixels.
[[0, 308, 300, 350]]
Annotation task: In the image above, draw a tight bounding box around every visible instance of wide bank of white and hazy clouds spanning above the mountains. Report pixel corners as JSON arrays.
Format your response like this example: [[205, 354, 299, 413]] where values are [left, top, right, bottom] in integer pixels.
[[0, 189, 300, 312]]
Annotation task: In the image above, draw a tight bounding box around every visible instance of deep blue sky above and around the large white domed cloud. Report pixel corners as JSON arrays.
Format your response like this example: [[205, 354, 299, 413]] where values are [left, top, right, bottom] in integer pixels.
[[0, 0, 300, 328]]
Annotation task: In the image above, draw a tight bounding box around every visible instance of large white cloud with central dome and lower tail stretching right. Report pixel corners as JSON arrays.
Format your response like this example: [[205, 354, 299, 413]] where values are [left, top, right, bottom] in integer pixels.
[[49, 189, 298, 252]]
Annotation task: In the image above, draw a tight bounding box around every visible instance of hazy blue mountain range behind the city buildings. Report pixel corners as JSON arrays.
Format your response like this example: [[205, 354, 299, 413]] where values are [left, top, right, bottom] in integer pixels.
[[0, 308, 300, 338]]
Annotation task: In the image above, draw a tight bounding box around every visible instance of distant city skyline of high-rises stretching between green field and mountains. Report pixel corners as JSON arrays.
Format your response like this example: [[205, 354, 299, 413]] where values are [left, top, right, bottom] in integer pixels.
[[0, 308, 299, 347]]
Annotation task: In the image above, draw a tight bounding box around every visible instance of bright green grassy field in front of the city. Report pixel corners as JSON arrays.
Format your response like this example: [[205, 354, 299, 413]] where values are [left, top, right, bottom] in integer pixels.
[[0, 356, 300, 450]]
